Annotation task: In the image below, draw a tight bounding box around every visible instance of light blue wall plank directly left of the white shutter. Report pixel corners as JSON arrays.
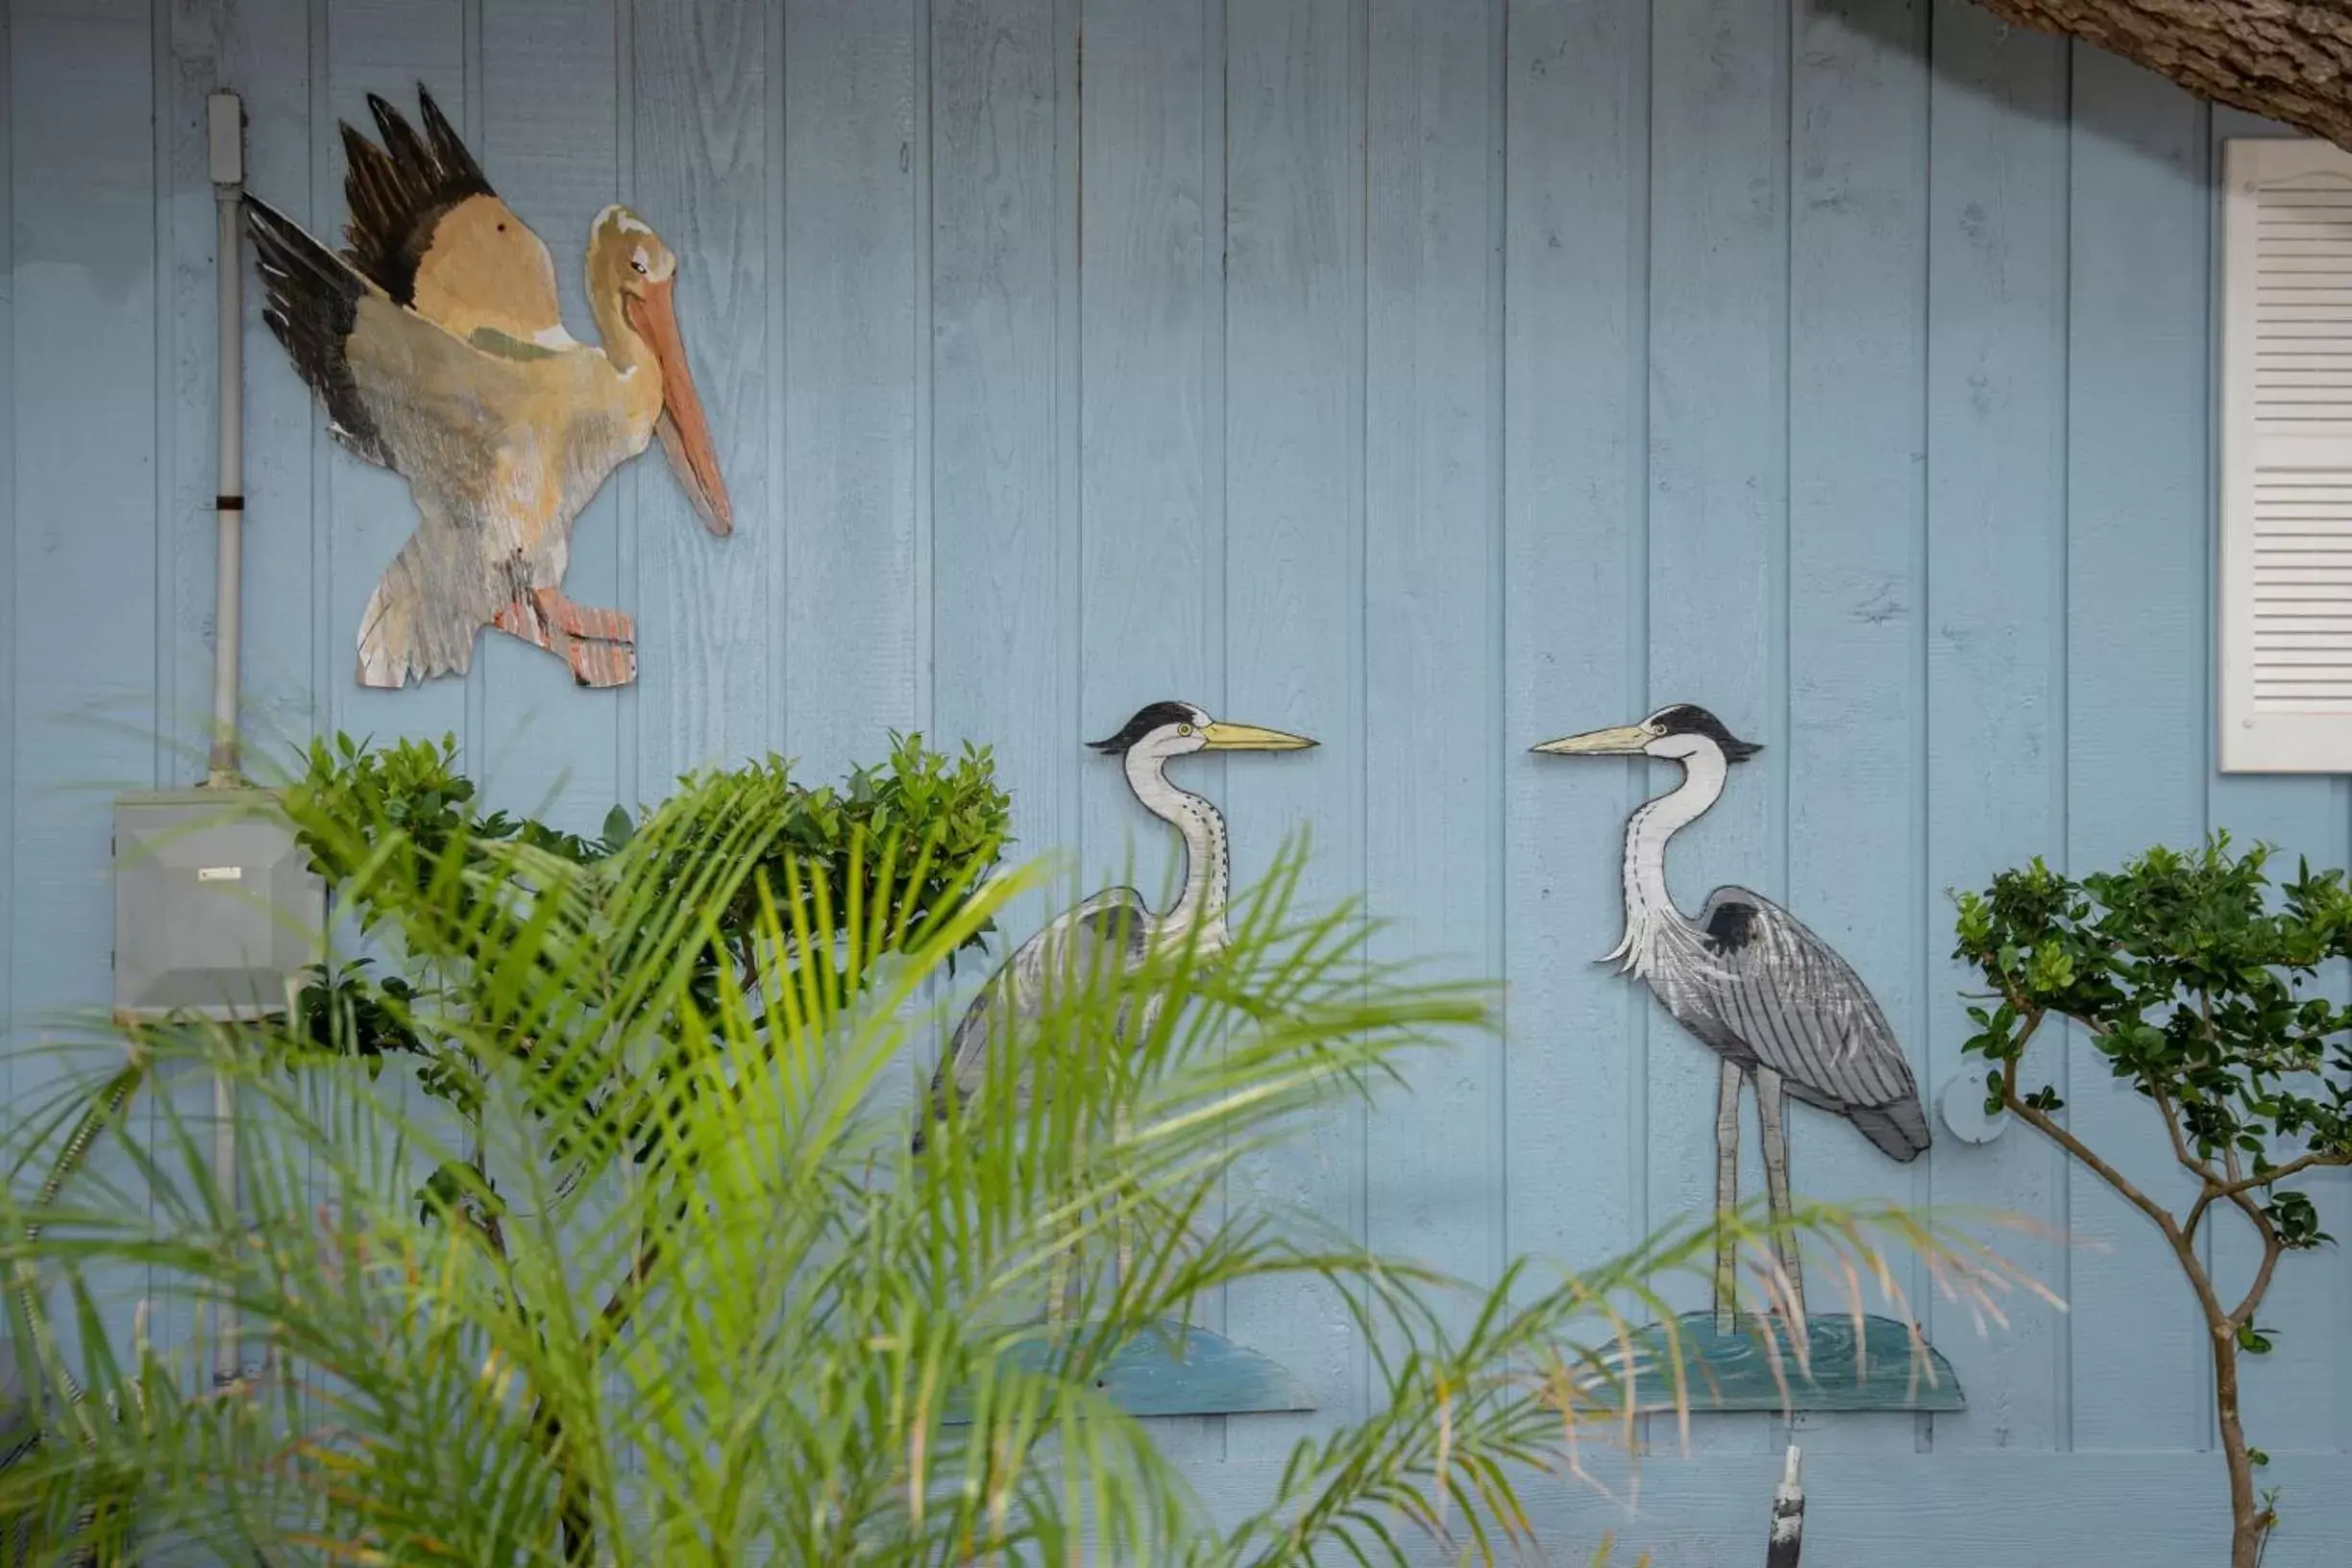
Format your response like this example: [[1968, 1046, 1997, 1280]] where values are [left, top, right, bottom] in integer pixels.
[[2065, 47, 2214, 1448]]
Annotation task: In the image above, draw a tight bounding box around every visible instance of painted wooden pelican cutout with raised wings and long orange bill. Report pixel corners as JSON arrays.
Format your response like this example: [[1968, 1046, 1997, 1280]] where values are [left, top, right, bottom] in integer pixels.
[[247, 87, 734, 686]]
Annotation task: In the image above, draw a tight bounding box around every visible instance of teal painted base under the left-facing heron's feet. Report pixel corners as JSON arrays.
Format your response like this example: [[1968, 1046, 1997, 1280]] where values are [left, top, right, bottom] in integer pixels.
[[1632, 1311, 1967, 1413]]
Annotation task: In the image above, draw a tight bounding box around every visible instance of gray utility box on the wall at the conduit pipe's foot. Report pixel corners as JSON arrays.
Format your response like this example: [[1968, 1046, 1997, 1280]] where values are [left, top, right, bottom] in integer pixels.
[[115, 790, 327, 1017]]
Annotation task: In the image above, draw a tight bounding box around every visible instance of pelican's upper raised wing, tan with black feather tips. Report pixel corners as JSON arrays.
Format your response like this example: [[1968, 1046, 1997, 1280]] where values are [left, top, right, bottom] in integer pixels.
[[343, 85, 562, 343]]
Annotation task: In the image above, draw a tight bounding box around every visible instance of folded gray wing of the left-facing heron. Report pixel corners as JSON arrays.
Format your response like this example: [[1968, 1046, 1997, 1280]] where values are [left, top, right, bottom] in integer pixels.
[[1694, 886, 1928, 1162]]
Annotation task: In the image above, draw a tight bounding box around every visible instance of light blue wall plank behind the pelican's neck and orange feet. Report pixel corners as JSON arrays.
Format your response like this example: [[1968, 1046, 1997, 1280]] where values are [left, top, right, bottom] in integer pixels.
[[475, 0, 621, 830]]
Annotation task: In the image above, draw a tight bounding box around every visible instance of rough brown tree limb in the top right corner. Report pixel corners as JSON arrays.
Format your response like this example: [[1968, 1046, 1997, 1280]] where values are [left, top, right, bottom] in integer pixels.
[[1978, 0, 2352, 148]]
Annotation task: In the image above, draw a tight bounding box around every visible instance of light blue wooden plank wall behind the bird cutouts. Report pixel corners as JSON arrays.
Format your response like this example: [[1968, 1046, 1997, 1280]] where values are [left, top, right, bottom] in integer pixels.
[[0, 0, 2352, 1568]]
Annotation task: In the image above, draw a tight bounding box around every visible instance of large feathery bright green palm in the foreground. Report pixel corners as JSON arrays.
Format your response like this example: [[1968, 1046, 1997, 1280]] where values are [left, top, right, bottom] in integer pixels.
[[0, 778, 2001, 1568]]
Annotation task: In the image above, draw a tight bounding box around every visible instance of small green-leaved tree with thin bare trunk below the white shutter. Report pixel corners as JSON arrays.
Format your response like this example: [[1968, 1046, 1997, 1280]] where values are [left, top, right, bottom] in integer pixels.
[[1957, 835, 2352, 1568]]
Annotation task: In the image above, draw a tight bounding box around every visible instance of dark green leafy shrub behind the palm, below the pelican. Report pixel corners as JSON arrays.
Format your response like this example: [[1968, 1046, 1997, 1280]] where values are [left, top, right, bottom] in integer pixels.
[[284, 736, 1012, 1235]]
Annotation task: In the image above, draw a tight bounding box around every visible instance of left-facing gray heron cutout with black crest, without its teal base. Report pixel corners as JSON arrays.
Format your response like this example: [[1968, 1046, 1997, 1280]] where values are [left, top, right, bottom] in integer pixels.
[[1536, 703, 1928, 1361]]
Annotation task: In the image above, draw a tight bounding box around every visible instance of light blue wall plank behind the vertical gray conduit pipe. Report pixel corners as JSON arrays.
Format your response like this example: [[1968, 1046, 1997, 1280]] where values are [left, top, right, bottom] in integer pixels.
[[158, 0, 317, 780]]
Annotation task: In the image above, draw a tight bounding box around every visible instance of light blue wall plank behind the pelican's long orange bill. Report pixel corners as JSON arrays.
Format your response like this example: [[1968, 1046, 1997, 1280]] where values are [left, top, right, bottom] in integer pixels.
[[621, 0, 771, 780]]
